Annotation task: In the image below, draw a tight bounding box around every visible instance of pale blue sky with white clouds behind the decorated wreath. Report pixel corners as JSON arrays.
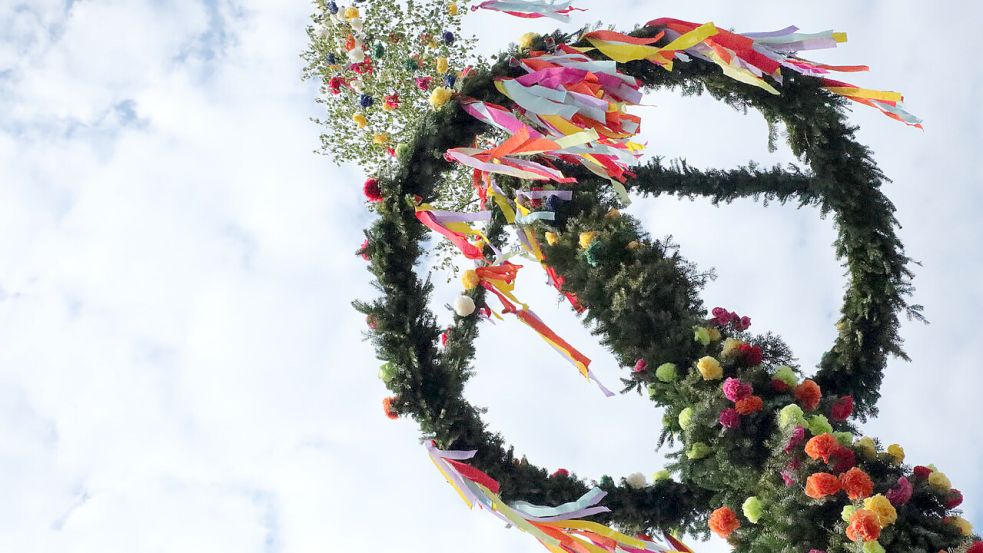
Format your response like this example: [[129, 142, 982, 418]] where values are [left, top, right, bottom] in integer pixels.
[[0, 0, 983, 553]]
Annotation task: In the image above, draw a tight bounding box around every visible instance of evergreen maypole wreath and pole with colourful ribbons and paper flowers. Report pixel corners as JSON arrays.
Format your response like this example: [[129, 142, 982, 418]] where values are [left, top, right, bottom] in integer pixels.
[[328, 10, 983, 553]]
